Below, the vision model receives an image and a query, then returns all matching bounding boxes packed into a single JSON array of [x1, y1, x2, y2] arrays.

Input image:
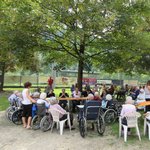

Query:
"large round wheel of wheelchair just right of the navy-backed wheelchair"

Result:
[[104, 109, 117, 124]]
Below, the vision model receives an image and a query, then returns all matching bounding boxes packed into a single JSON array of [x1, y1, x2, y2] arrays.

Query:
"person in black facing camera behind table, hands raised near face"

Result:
[[59, 88, 69, 110]]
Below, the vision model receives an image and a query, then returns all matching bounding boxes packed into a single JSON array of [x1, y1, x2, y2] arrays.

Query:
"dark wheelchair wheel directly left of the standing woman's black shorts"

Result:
[[12, 109, 23, 125]]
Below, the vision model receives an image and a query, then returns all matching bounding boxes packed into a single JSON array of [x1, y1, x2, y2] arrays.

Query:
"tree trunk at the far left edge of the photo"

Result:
[[0, 62, 5, 92]]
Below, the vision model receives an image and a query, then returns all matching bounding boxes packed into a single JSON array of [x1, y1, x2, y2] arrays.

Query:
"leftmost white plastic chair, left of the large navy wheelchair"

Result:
[[50, 109, 71, 135]]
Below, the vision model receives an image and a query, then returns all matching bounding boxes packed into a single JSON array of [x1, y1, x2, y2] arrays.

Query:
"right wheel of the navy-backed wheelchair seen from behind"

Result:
[[97, 115, 105, 135]]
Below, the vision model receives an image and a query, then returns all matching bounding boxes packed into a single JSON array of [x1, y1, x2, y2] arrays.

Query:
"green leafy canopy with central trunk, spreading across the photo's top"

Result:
[[0, 0, 150, 89]]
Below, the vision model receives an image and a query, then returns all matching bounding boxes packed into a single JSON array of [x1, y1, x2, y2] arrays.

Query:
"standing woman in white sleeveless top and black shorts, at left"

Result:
[[22, 82, 36, 129]]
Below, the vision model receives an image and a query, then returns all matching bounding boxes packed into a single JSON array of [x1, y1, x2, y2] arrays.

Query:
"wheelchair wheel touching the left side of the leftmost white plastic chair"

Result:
[[40, 115, 53, 132]]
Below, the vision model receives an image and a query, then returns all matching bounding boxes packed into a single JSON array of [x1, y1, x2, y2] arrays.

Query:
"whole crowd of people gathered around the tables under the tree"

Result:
[[8, 80, 150, 134]]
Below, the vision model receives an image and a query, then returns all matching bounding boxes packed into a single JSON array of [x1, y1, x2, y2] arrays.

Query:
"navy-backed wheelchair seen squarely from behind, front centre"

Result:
[[77, 100, 105, 138]]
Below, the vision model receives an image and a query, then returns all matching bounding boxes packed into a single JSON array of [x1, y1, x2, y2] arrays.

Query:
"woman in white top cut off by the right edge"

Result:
[[144, 80, 150, 112]]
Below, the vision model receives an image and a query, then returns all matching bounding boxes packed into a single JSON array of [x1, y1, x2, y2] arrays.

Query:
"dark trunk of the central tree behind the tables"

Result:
[[78, 60, 83, 91]]
